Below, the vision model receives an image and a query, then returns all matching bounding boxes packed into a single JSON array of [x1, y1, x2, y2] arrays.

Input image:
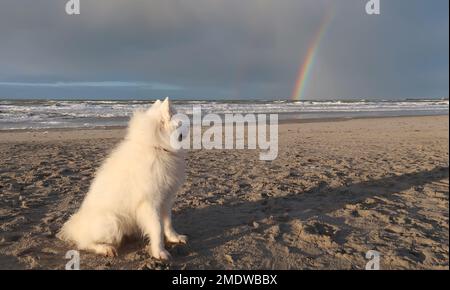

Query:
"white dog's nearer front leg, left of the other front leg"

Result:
[[136, 203, 170, 260]]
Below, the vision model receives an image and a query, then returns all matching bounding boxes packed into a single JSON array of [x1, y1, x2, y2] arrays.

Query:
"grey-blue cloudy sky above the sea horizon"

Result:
[[0, 0, 449, 100]]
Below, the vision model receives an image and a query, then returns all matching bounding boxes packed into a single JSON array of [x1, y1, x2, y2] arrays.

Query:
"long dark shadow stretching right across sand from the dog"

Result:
[[174, 167, 449, 264]]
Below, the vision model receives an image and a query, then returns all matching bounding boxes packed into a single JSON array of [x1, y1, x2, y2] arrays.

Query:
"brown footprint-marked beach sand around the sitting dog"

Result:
[[0, 116, 449, 269]]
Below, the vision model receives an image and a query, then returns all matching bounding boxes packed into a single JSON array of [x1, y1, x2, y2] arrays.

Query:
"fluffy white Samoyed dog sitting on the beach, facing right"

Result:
[[57, 98, 187, 260]]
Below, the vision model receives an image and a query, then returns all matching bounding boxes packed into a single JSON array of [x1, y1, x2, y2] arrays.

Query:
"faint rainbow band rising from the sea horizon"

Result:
[[291, 12, 332, 101]]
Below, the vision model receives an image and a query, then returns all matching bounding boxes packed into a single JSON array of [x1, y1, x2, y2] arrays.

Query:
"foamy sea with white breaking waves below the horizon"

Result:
[[0, 99, 449, 130]]
